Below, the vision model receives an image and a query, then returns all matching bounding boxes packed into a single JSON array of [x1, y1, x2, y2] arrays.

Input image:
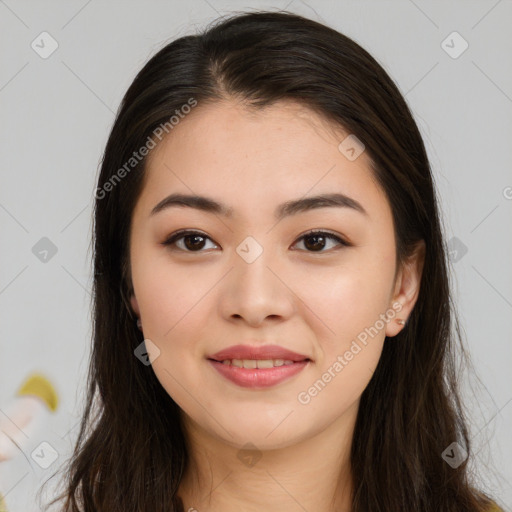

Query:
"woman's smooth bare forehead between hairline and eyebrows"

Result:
[[138, 101, 389, 221]]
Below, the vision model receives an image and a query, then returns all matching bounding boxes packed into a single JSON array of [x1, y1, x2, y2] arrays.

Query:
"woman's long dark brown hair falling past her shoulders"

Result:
[[39, 11, 500, 512]]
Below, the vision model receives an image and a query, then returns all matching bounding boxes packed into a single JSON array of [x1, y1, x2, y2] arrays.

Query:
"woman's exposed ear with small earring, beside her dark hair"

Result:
[[386, 240, 425, 337]]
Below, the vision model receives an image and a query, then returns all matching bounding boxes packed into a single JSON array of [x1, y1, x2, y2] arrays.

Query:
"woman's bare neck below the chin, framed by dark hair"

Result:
[[179, 402, 359, 512]]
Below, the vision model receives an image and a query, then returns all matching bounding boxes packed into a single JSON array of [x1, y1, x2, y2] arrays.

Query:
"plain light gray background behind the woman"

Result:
[[0, 0, 512, 512]]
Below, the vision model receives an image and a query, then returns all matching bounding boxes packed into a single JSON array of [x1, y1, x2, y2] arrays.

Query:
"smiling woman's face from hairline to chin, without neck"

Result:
[[130, 98, 420, 448]]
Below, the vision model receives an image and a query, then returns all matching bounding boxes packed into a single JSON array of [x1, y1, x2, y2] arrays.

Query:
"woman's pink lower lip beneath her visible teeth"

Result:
[[208, 359, 309, 388]]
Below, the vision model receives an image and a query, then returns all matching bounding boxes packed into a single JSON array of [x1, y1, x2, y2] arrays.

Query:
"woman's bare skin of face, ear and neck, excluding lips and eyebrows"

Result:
[[130, 100, 424, 512]]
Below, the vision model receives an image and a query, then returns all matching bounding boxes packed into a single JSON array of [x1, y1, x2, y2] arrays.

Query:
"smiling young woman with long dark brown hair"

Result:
[[42, 12, 502, 512]]
